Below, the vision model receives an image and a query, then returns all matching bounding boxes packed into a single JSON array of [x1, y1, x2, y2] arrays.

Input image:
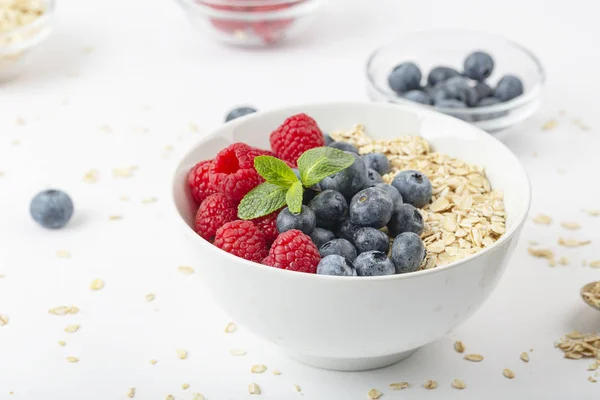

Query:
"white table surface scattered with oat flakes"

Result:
[[0, 0, 600, 400]]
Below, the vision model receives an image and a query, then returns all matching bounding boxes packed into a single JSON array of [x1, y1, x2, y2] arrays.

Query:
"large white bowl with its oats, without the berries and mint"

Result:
[[172, 102, 530, 371]]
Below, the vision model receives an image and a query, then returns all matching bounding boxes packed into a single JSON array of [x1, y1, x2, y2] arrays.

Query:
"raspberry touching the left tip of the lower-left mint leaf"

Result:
[[195, 193, 237, 240]]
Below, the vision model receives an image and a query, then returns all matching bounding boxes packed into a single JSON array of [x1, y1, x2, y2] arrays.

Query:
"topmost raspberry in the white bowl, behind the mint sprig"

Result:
[[271, 114, 325, 166]]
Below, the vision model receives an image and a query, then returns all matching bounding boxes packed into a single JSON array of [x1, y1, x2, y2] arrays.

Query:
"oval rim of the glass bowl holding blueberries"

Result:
[[365, 29, 546, 116]]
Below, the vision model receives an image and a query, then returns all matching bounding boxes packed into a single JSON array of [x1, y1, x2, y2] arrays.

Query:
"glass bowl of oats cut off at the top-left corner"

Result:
[[0, 0, 55, 82]]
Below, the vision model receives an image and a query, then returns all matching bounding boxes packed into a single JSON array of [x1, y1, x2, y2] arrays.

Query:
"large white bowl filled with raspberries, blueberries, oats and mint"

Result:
[[172, 102, 530, 370]]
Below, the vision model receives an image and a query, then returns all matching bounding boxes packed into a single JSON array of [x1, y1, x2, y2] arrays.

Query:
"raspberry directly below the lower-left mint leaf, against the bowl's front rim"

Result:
[[214, 221, 268, 262]]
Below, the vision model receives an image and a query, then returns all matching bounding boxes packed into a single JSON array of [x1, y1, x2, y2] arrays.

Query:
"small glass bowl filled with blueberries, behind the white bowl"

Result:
[[367, 30, 545, 132]]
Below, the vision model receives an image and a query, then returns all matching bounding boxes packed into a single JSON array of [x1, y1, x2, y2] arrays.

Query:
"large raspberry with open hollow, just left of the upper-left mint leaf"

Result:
[[210, 143, 271, 201]]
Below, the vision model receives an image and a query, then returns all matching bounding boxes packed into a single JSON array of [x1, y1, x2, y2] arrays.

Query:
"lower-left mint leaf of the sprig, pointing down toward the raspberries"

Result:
[[238, 182, 288, 220]]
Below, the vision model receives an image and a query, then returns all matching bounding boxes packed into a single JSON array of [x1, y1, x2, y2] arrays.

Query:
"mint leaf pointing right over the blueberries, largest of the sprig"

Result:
[[298, 147, 354, 187]]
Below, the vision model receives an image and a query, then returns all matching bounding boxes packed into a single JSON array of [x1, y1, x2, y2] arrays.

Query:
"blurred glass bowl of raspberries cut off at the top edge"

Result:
[[178, 0, 322, 47]]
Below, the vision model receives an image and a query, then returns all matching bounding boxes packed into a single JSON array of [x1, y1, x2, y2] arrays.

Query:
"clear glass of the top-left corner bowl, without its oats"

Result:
[[0, 0, 55, 82]]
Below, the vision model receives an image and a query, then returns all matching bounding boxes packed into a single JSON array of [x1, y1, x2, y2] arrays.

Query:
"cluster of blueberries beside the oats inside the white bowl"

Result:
[[277, 141, 432, 276]]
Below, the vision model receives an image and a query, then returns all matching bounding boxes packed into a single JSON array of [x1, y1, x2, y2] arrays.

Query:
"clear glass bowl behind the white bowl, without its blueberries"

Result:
[[366, 30, 545, 132]]
